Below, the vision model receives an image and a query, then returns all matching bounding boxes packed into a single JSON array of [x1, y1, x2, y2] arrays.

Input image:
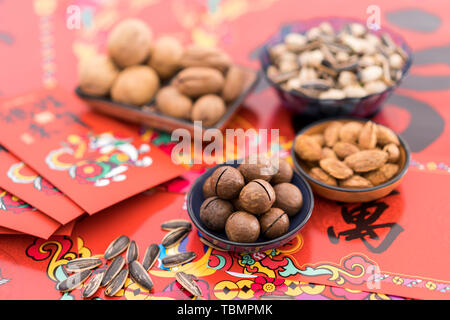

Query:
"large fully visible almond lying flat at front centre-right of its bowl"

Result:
[[344, 149, 388, 172]]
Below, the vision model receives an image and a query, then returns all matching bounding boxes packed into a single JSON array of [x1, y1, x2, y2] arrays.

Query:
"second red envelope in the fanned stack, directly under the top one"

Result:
[[0, 146, 84, 224]]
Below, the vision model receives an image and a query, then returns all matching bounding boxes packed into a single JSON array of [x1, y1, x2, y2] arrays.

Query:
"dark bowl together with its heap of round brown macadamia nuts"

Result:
[[187, 155, 314, 252]]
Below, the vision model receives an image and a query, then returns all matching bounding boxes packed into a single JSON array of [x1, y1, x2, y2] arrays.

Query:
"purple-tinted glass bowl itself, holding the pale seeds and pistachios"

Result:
[[259, 18, 412, 118]]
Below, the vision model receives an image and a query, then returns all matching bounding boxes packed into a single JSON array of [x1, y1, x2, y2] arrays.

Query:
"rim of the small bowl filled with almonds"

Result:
[[291, 116, 411, 193]]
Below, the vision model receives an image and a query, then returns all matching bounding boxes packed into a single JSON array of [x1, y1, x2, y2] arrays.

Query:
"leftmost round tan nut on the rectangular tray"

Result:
[[79, 55, 119, 96]]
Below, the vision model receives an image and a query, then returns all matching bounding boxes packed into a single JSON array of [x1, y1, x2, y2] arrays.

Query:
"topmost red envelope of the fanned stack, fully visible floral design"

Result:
[[0, 88, 185, 214]]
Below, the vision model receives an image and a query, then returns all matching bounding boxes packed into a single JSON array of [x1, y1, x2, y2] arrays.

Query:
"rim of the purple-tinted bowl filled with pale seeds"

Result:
[[258, 16, 413, 103]]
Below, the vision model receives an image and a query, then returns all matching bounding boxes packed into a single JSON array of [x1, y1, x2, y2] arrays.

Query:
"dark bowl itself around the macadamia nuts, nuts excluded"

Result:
[[187, 161, 314, 252]]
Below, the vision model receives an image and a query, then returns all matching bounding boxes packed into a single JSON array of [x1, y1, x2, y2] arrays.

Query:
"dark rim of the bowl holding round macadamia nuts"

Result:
[[186, 160, 314, 248]]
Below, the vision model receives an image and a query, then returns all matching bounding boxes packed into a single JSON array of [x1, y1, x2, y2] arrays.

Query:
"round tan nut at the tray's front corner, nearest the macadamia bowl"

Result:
[[191, 94, 226, 127]]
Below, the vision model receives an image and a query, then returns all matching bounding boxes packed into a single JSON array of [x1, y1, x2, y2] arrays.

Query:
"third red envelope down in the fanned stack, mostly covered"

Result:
[[0, 189, 61, 239]]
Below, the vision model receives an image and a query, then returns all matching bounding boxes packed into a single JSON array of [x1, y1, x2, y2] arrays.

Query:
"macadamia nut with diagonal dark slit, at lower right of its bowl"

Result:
[[259, 208, 289, 239]]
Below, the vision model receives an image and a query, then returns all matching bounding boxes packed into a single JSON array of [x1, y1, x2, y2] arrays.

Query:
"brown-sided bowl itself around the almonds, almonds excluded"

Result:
[[291, 118, 411, 202]]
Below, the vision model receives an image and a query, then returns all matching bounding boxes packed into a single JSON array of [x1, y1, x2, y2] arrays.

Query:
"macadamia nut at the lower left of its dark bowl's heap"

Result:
[[200, 196, 234, 231]]
